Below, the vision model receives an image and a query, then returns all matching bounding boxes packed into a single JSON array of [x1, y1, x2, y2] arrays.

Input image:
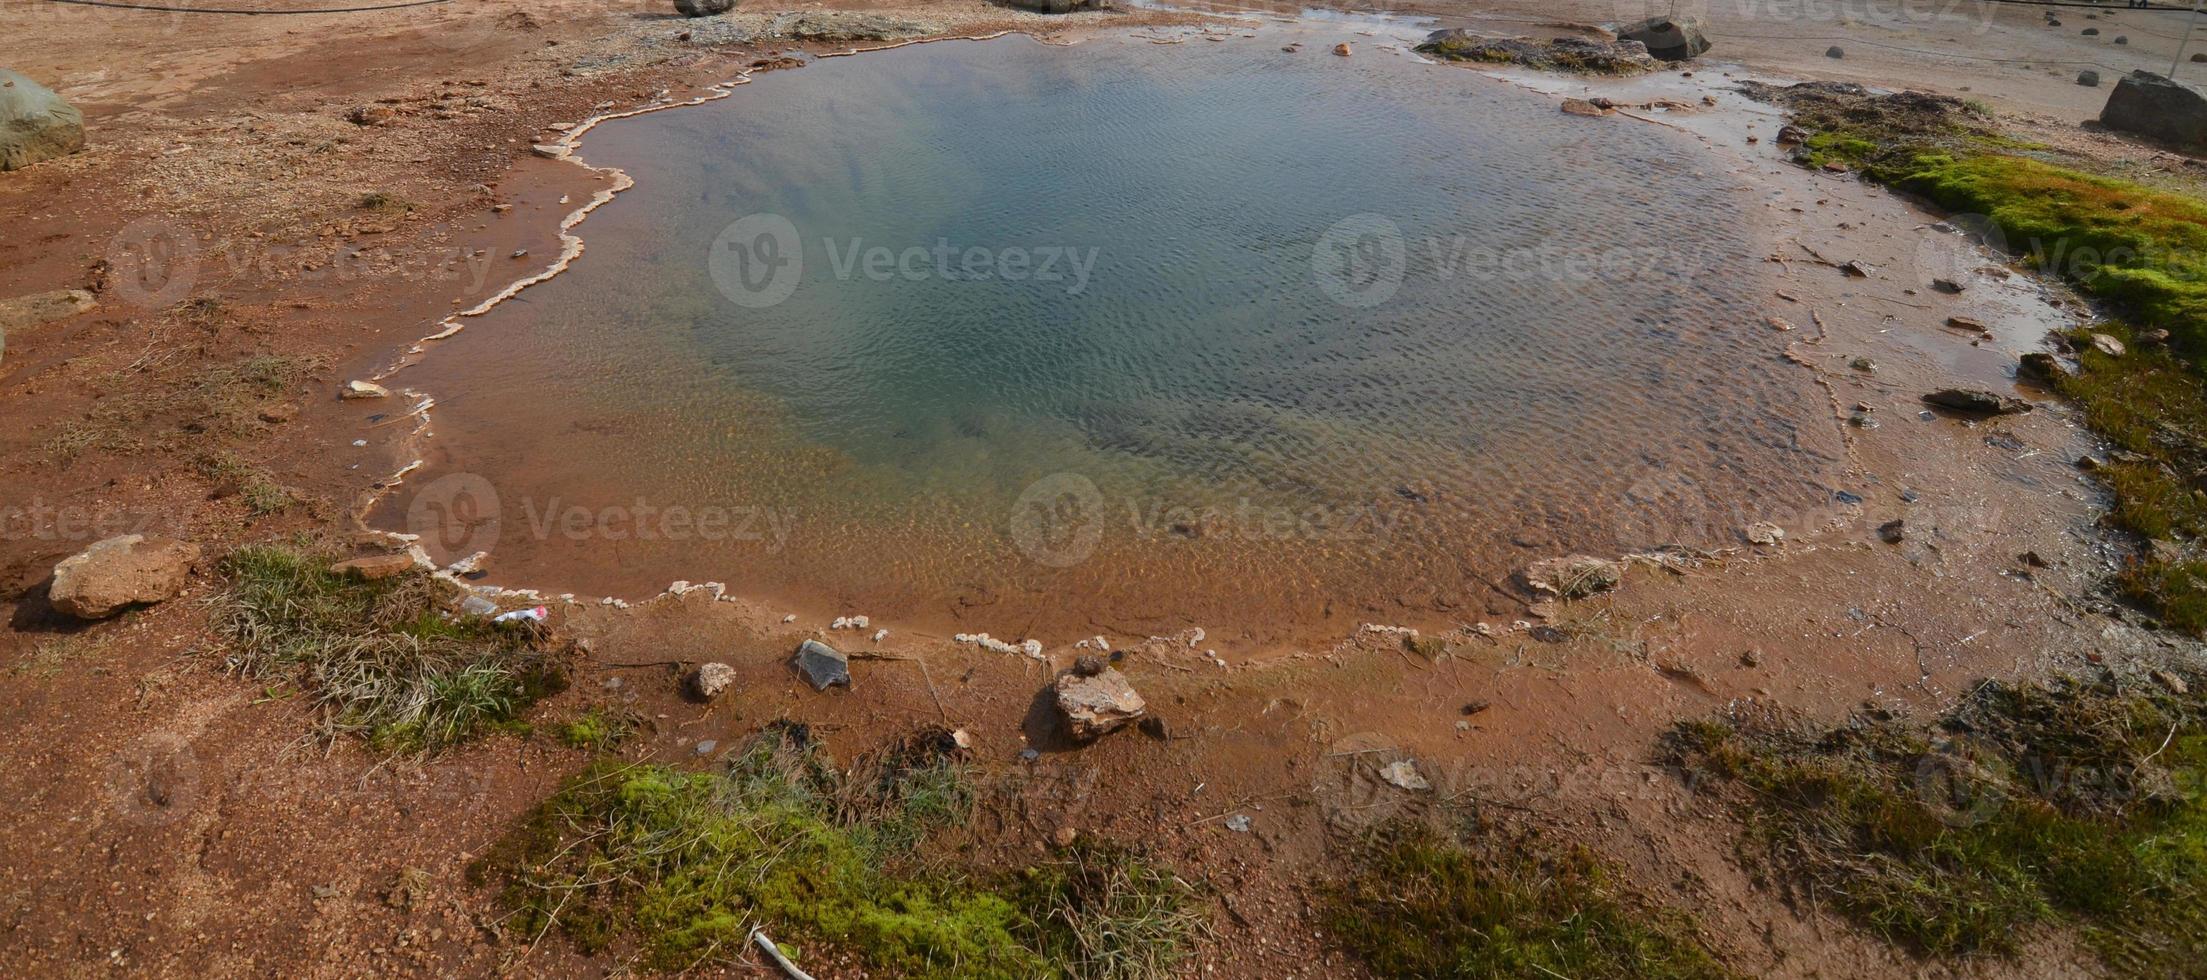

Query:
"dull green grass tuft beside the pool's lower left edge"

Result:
[[214, 545, 565, 753]]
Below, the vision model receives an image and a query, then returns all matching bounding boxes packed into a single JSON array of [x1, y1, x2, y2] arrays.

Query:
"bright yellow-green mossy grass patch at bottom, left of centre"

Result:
[[475, 724, 1201, 978]]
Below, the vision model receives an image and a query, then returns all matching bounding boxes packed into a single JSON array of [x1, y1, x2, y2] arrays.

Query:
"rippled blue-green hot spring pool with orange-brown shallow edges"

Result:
[[392, 33, 1838, 642]]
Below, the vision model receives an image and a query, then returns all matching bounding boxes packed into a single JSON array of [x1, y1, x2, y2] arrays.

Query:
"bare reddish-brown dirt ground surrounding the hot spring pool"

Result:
[[0, 0, 2198, 976]]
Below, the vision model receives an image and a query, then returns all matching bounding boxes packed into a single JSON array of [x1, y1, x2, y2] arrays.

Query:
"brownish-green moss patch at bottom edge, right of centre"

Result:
[[1322, 821, 1732, 978]]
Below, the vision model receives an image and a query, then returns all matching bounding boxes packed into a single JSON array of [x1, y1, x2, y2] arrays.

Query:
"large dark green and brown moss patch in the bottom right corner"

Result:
[[1666, 680, 2207, 976]]
